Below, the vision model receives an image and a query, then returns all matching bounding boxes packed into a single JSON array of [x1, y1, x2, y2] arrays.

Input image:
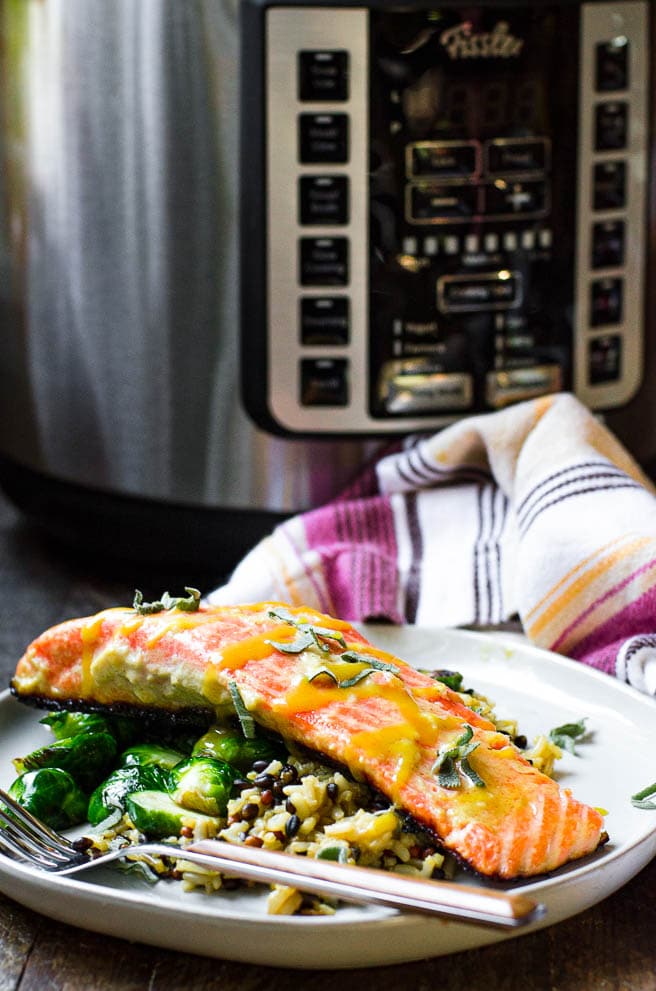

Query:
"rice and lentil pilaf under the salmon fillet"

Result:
[[83, 691, 561, 915]]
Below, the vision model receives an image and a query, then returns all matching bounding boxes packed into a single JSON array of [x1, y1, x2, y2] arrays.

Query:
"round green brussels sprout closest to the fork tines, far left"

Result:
[[9, 767, 87, 829]]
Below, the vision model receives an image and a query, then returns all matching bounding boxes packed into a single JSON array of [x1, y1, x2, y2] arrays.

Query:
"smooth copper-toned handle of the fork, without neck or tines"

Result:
[[179, 840, 545, 928]]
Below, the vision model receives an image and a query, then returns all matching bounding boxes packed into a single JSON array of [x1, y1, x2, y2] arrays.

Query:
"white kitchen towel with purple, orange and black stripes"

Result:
[[208, 393, 656, 694]]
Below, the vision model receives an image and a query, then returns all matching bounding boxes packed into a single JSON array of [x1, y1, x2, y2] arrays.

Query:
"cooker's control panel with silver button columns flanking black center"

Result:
[[253, 0, 648, 434]]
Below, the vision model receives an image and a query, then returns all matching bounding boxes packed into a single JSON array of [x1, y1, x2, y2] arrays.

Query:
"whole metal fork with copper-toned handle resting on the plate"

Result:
[[0, 789, 545, 928]]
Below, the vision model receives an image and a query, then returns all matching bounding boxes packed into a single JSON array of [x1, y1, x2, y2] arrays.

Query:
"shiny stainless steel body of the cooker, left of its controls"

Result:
[[0, 0, 380, 511]]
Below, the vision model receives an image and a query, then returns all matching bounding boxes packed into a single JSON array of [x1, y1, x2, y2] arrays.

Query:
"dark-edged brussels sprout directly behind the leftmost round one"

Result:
[[13, 733, 116, 792]]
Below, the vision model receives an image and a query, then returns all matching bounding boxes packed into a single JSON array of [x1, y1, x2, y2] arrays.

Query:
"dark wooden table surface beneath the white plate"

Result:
[[0, 496, 656, 991]]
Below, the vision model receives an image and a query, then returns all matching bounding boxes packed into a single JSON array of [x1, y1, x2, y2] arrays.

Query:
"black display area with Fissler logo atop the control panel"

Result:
[[372, 8, 555, 140]]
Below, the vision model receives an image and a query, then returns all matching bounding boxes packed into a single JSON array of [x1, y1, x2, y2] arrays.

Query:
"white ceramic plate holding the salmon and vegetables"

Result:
[[0, 626, 656, 969]]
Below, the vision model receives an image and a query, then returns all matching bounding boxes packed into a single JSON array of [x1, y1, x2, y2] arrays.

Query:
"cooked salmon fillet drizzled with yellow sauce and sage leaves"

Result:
[[12, 603, 604, 879]]
